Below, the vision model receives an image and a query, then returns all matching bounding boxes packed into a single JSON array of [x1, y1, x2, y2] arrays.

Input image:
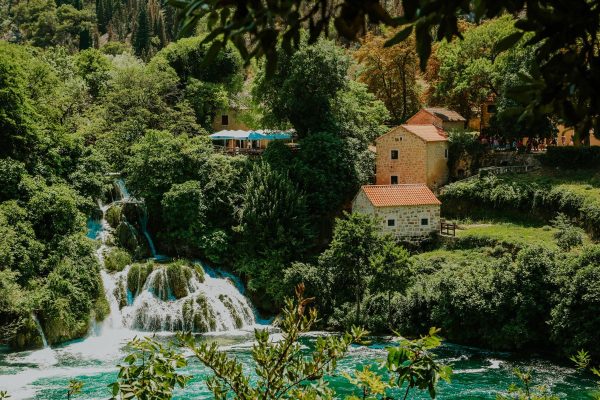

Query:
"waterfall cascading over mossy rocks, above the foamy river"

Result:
[[96, 179, 256, 332]]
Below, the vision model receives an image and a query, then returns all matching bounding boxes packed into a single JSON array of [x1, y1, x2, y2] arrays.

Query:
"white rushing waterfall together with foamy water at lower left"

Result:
[[0, 180, 265, 399]]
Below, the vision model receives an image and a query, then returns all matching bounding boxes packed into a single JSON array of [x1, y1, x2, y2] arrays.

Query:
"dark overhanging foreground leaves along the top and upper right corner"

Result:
[[171, 0, 600, 136]]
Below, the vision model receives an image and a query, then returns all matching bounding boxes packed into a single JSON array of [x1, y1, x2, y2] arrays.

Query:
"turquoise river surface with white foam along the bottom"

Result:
[[0, 328, 597, 400]]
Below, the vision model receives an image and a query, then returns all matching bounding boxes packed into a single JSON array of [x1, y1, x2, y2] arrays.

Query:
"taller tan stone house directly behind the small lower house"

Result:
[[375, 124, 448, 190]]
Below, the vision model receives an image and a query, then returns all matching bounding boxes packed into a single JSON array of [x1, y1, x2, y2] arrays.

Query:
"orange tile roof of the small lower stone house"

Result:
[[361, 184, 442, 207]]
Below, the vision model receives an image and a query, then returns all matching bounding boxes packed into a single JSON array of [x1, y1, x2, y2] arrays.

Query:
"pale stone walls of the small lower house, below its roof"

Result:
[[352, 190, 440, 241]]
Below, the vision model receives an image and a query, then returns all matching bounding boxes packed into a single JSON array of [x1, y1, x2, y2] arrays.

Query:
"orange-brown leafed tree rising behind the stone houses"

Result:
[[354, 29, 420, 124]]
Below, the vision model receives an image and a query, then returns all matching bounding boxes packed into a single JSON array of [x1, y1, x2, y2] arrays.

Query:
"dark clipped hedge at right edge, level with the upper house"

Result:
[[540, 146, 600, 169]]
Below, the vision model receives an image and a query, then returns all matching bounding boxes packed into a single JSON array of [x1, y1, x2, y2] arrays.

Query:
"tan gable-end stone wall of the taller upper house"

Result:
[[375, 126, 427, 185]]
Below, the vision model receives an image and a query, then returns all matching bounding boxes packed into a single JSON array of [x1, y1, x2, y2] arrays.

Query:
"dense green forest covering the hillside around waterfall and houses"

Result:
[[0, 0, 600, 396]]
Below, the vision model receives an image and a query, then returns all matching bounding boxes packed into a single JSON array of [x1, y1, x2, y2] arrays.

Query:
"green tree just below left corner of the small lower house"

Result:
[[319, 213, 381, 323]]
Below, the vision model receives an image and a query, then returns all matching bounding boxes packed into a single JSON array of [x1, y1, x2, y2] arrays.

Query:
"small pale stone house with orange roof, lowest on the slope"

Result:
[[352, 184, 442, 242]]
